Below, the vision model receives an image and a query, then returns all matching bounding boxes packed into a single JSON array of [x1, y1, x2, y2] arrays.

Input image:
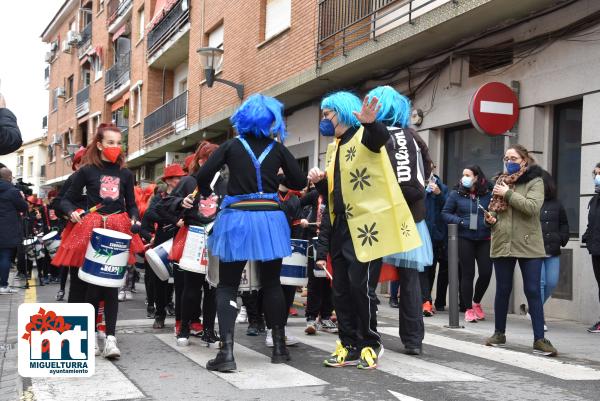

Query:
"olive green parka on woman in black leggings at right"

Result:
[[490, 165, 546, 258]]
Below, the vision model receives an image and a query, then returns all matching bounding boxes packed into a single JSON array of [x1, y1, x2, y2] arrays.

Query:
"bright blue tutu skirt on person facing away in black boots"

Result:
[[208, 208, 292, 262]]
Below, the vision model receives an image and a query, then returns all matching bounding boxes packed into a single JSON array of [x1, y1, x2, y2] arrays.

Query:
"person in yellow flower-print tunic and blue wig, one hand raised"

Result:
[[309, 92, 420, 369]]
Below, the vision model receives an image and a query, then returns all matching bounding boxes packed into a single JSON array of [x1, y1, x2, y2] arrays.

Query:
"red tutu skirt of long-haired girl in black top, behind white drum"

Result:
[[52, 213, 144, 267]]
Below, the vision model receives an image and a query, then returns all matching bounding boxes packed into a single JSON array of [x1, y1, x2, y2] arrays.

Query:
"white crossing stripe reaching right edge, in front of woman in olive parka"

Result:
[[379, 327, 600, 380]]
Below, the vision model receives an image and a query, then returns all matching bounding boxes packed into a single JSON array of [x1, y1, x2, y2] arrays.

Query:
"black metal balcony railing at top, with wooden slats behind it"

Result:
[[316, 0, 458, 64]]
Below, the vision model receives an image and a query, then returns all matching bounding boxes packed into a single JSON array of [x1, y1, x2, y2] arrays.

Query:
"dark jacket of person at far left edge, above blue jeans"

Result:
[[0, 180, 27, 248]]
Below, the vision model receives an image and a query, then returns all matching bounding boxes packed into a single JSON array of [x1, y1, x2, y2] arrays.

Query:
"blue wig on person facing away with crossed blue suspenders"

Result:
[[230, 93, 287, 143]]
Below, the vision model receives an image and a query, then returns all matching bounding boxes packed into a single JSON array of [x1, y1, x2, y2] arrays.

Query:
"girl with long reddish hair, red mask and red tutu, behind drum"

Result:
[[54, 124, 144, 358]]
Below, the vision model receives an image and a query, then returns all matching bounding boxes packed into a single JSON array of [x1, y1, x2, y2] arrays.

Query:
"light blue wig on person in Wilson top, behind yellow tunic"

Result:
[[367, 85, 411, 128]]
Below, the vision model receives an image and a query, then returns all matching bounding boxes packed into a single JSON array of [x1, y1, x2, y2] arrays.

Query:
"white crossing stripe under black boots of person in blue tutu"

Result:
[[156, 333, 329, 390]]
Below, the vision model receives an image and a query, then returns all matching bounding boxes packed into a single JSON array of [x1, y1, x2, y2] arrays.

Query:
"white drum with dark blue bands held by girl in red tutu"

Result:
[[79, 228, 131, 288]]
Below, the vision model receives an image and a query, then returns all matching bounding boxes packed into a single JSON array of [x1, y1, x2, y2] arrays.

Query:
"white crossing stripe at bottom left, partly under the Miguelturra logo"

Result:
[[31, 357, 145, 401]]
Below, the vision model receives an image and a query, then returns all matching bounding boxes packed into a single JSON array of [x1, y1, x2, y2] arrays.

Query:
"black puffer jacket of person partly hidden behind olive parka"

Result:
[[540, 199, 569, 256]]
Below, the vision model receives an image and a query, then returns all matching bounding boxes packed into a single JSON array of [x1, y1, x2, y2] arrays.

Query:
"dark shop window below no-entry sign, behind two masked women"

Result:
[[444, 124, 504, 188]]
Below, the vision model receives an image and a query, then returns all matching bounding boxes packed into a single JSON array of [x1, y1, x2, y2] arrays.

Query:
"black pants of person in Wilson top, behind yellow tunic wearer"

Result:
[[398, 268, 425, 348]]
